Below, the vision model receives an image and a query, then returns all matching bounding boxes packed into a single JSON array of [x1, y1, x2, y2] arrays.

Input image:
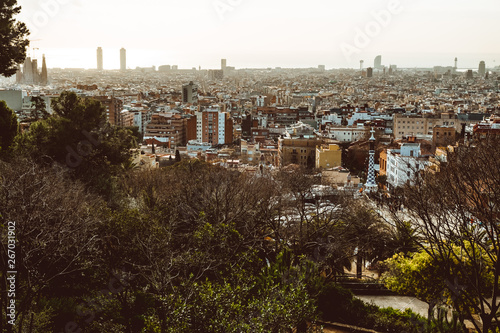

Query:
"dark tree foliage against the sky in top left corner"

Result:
[[0, 0, 29, 77]]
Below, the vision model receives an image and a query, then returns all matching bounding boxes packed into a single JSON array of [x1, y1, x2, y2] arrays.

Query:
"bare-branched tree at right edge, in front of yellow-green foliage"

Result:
[[394, 136, 500, 333]]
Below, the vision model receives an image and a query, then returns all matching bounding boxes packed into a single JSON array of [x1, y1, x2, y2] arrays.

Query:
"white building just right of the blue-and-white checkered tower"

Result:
[[386, 143, 429, 189]]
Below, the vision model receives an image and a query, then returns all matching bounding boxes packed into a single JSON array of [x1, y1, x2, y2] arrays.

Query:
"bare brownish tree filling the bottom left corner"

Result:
[[0, 158, 103, 332]]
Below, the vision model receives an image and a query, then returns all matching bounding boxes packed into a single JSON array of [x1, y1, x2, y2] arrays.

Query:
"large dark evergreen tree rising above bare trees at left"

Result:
[[17, 92, 136, 194]]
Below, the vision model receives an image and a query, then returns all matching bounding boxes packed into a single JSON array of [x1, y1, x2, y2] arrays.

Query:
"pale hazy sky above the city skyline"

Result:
[[18, 0, 500, 69]]
